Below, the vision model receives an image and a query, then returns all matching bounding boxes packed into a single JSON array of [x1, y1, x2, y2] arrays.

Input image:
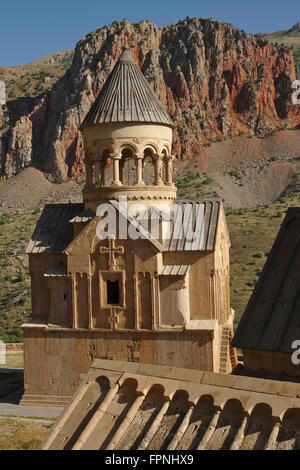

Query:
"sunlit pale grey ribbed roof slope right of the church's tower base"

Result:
[[165, 200, 222, 251]]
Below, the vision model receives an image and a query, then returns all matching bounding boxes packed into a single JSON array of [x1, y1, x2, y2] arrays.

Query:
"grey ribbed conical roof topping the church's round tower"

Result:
[[81, 50, 174, 129]]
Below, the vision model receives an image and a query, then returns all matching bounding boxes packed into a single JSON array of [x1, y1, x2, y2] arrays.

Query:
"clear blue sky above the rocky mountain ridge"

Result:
[[0, 0, 300, 66]]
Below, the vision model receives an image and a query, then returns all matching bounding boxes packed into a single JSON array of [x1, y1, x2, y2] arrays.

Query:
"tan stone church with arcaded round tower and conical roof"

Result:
[[22, 48, 236, 405]]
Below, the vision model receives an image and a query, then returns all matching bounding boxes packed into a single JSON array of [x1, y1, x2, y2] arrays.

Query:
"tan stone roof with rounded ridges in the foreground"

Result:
[[42, 359, 300, 450]]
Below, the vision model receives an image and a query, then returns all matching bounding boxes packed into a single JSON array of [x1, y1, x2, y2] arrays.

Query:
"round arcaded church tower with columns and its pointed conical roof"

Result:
[[81, 48, 176, 211]]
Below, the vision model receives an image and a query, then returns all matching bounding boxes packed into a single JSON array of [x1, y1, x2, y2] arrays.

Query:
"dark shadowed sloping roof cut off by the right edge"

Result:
[[232, 208, 300, 353]]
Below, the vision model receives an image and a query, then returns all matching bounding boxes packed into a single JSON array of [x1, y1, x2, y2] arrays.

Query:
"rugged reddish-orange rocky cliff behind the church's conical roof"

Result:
[[0, 18, 300, 179]]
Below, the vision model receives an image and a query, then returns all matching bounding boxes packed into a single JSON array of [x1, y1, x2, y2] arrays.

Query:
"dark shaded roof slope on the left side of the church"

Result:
[[26, 204, 84, 253]]
